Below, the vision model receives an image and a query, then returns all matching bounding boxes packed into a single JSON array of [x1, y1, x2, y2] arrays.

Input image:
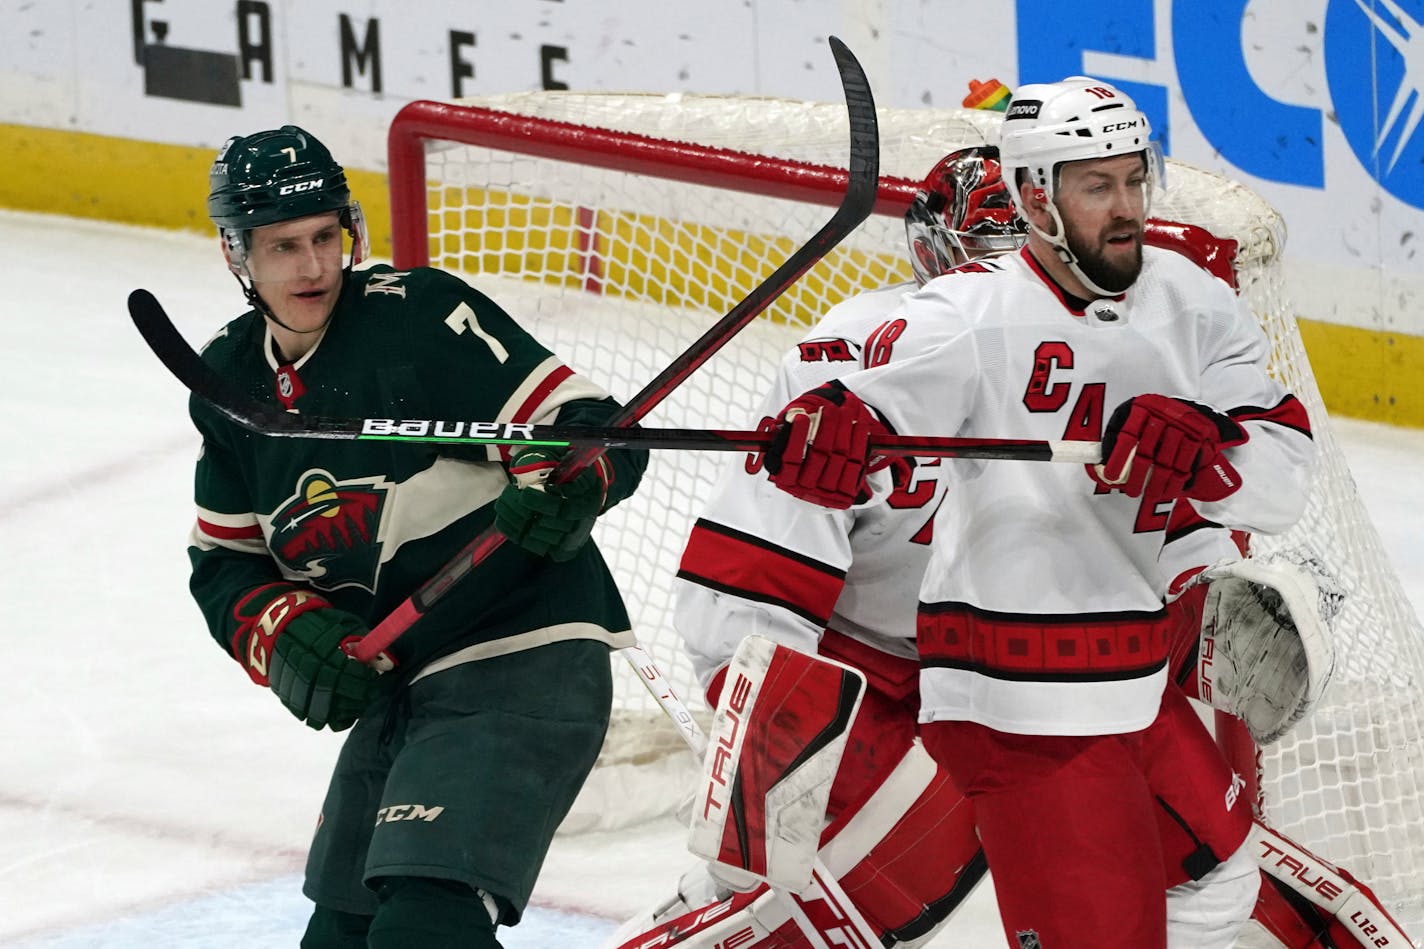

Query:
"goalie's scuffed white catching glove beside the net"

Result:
[[1196, 560, 1341, 745]]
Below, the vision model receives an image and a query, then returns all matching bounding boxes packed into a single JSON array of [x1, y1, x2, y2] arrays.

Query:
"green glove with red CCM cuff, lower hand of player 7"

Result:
[[232, 583, 377, 731]]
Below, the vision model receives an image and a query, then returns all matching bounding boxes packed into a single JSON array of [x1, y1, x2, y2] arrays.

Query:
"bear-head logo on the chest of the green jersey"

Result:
[[271, 470, 390, 593]]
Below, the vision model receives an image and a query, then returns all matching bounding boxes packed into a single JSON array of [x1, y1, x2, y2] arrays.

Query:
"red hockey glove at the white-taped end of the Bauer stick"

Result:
[[1094, 395, 1247, 502]]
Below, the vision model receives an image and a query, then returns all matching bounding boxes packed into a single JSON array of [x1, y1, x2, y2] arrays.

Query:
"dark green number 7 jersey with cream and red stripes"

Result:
[[189, 266, 646, 665]]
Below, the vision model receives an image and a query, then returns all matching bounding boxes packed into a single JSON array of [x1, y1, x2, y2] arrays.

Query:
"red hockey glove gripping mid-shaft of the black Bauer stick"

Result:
[[766, 382, 887, 509]]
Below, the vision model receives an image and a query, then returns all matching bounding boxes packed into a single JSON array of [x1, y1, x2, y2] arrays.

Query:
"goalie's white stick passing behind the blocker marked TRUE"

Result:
[[618, 645, 880, 949]]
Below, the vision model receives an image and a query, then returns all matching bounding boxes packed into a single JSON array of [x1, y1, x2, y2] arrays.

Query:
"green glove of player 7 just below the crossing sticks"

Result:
[[494, 447, 609, 560]]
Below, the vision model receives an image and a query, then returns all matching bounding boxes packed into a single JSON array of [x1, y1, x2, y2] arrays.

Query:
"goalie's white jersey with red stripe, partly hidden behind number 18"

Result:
[[676, 277, 944, 685]]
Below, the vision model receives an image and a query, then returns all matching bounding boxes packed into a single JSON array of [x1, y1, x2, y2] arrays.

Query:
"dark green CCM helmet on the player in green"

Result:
[[208, 125, 370, 278]]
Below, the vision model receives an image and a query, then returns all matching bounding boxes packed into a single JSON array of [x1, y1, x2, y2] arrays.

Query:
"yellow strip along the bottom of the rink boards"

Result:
[[0, 124, 1424, 427]]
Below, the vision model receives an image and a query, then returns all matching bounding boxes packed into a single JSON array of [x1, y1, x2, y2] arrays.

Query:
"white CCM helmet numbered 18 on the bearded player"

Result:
[[998, 76, 1165, 296]]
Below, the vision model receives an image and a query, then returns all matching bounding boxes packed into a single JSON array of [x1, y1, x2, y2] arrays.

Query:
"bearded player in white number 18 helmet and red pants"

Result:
[[768, 80, 1313, 949]]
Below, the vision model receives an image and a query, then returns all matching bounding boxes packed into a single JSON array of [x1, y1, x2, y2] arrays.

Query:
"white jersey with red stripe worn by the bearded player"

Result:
[[842, 247, 1313, 735]]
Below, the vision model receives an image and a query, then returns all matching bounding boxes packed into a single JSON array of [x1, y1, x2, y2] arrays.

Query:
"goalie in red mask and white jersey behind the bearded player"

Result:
[[607, 140, 1412, 949]]
